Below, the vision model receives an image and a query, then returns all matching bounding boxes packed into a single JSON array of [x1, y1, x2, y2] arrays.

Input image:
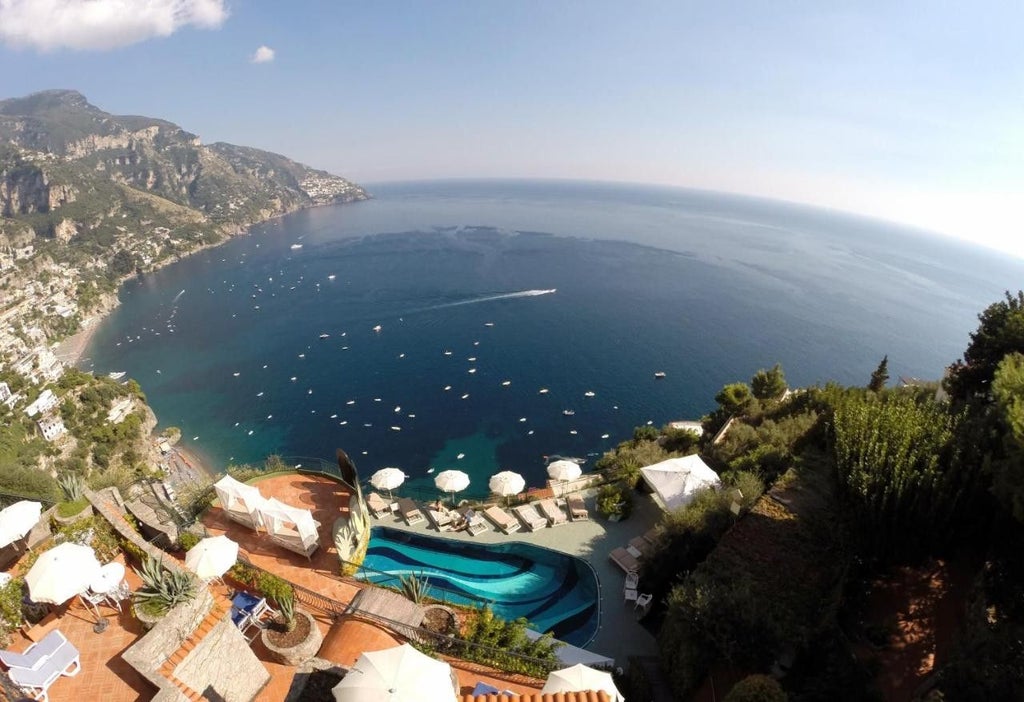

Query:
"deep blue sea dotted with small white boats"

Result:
[[83, 180, 1024, 496]]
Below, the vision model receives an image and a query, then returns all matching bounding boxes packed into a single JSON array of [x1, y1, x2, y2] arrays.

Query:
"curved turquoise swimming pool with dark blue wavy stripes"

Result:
[[360, 527, 600, 647]]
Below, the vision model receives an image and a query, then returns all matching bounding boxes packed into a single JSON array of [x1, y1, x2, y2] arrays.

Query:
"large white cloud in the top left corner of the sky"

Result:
[[0, 0, 227, 51]]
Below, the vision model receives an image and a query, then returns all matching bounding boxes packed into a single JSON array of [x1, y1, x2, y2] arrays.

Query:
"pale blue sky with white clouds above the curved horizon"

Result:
[[0, 0, 1024, 258]]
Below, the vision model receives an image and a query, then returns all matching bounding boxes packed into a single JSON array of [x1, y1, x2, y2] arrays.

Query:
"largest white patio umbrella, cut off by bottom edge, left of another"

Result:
[[331, 644, 456, 702]]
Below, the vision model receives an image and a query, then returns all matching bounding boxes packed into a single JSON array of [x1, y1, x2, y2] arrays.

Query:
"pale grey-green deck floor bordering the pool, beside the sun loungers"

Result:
[[372, 496, 663, 667]]
